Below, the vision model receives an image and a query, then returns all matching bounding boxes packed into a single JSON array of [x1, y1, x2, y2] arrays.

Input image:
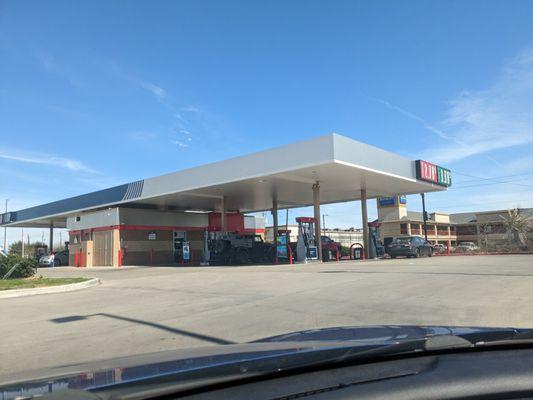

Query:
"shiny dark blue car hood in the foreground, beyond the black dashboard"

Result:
[[0, 325, 533, 399]]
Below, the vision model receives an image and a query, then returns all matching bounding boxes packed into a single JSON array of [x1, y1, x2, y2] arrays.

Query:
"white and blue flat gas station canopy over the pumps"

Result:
[[2, 134, 446, 228]]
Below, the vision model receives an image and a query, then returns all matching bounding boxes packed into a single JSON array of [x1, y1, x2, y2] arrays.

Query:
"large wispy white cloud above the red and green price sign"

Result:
[[425, 50, 533, 162]]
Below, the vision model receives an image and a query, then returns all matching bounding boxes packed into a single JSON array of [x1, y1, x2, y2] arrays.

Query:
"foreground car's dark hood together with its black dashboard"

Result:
[[0, 326, 533, 400]]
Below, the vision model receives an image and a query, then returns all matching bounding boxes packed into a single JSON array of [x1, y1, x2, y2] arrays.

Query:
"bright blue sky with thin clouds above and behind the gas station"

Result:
[[0, 0, 533, 245]]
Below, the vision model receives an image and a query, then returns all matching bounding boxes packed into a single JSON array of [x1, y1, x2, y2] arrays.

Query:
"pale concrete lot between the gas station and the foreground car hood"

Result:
[[0, 255, 533, 381]]
